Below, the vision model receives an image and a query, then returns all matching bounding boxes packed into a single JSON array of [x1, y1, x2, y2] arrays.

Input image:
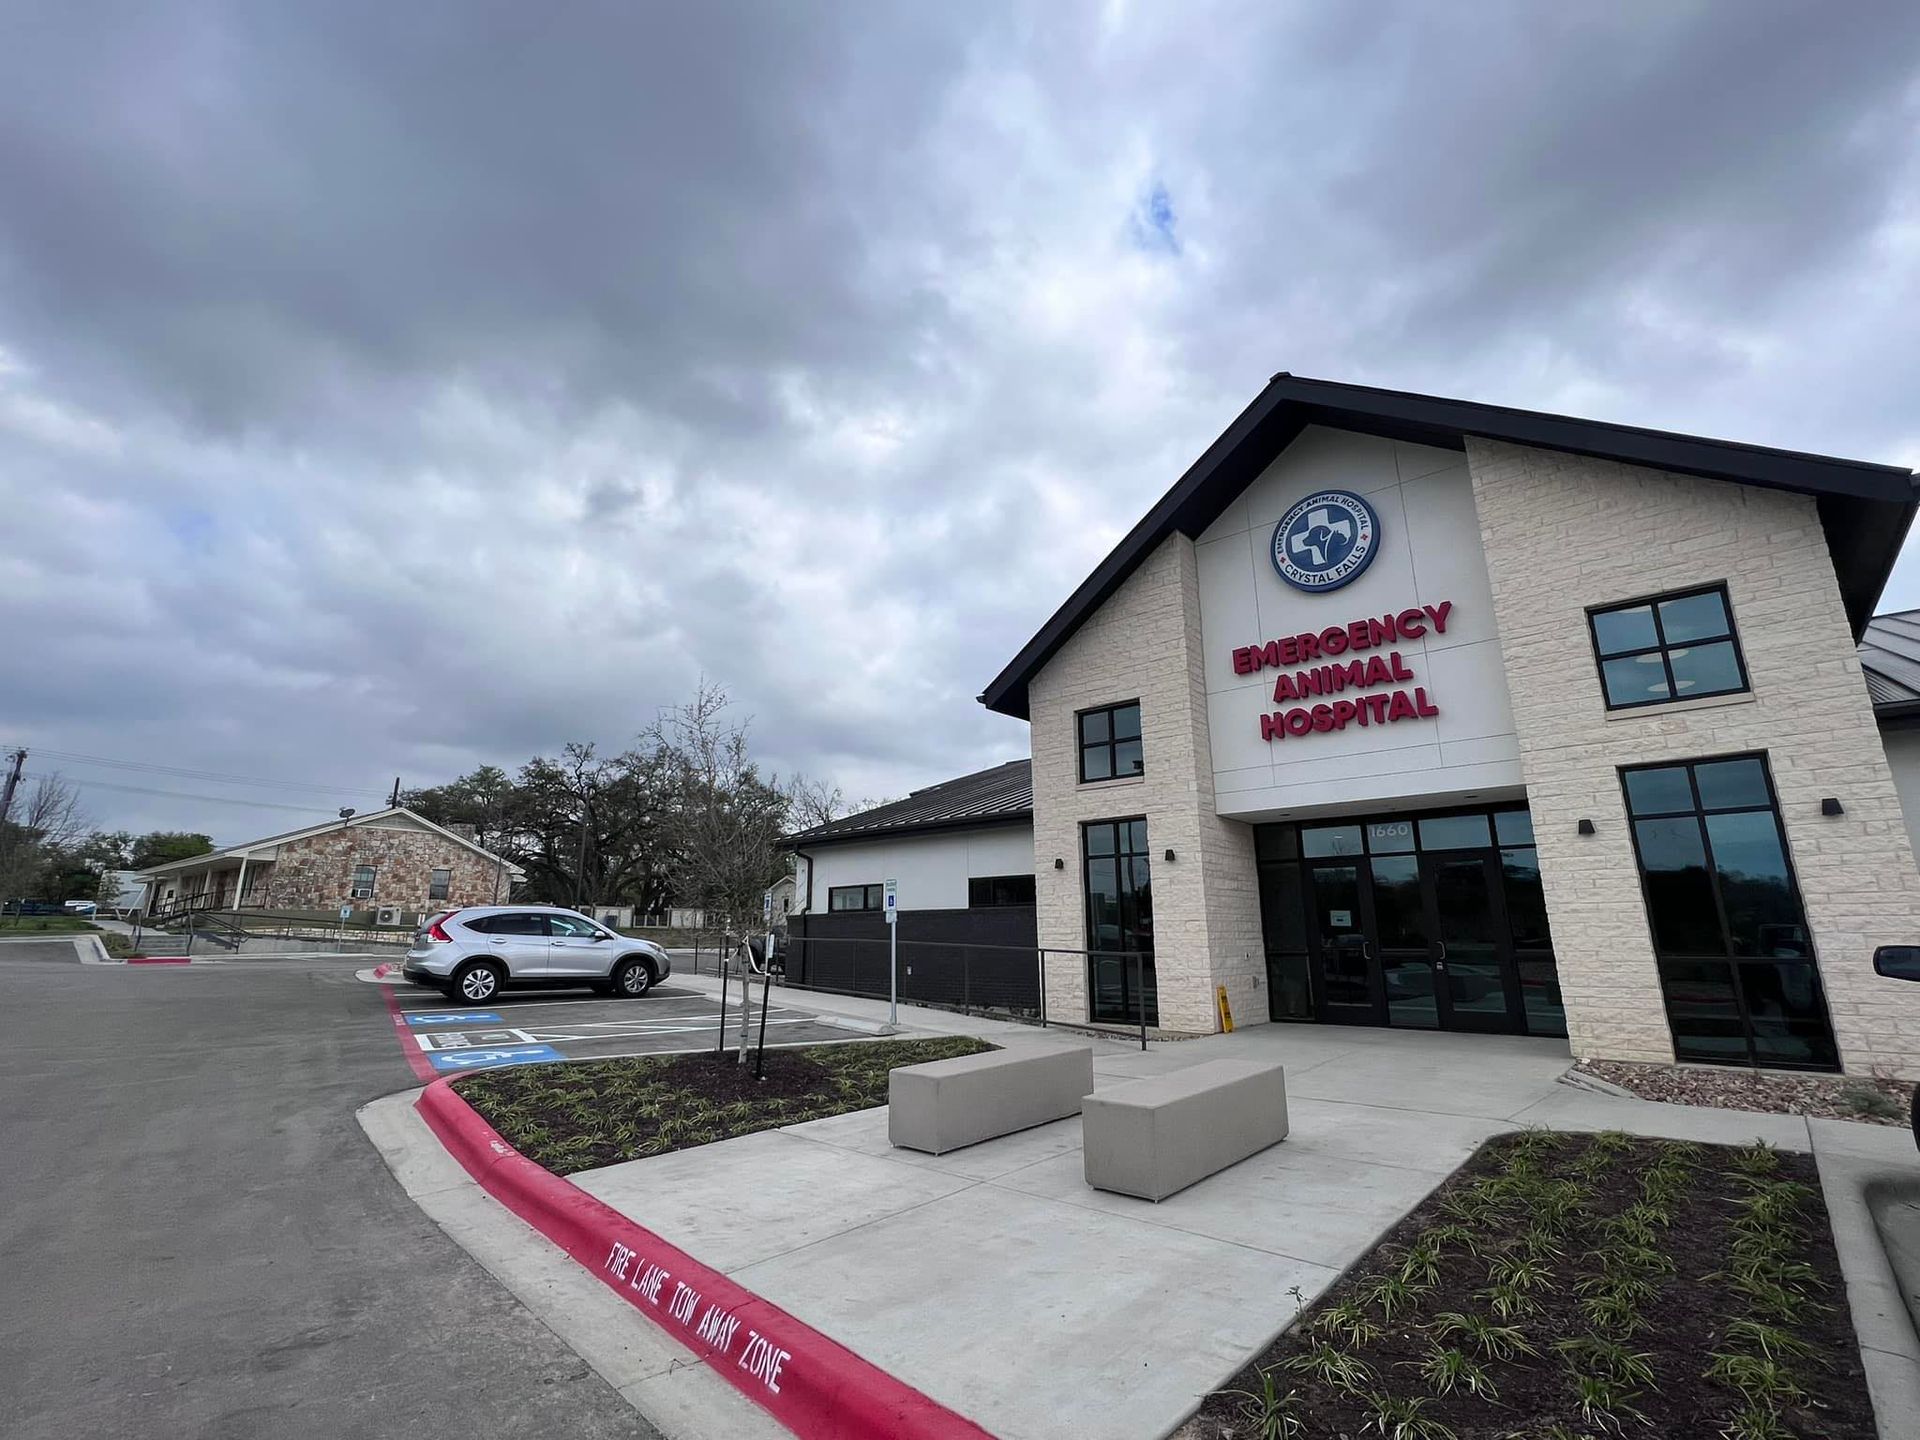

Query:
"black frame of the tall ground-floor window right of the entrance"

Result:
[[1617, 751, 1841, 1073]]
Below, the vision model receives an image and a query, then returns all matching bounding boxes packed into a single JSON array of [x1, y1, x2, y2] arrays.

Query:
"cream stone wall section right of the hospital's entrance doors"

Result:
[[1467, 438, 1920, 1077]]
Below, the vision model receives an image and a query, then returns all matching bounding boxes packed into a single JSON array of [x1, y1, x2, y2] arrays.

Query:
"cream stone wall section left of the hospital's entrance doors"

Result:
[[1027, 536, 1267, 1031]]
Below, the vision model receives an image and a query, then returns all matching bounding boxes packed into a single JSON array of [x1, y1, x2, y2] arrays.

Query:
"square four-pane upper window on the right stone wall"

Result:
[[1586, 586, 1749, 710]]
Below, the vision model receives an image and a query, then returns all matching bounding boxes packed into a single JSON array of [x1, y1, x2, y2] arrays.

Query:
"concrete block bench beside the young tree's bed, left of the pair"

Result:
[[887, 1041, 1092, 1156]]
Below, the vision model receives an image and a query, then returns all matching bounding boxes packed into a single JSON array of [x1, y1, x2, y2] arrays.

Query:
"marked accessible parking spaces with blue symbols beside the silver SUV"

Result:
[[392, 981, 858, 1073]]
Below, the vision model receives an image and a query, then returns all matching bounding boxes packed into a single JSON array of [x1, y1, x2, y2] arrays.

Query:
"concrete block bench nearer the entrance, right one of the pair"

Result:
[[1081, 1060, 1286, 1200]]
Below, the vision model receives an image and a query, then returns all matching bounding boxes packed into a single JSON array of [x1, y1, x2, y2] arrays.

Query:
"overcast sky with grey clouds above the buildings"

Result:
[[0, 0, 1920, 841]]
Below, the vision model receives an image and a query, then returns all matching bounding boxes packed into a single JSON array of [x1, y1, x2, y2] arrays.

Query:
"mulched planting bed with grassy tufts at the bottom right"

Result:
[[1181, 1131, 1874, 1440]]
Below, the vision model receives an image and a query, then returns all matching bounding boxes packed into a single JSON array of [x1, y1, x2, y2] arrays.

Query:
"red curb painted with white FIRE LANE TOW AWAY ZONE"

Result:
[[417, 1079, 993, 1440]]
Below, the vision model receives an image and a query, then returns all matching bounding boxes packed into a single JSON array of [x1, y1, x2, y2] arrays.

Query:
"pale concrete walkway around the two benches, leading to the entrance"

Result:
[[574, 1013, 1920, 1440]]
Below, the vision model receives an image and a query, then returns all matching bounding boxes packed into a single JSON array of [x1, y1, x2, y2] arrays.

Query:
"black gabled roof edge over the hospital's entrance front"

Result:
[[979, 371, 1914, 720]]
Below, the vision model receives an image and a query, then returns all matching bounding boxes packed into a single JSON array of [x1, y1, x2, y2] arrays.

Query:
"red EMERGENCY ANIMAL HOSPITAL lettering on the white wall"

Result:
[[1233, 601, 1453, 741]]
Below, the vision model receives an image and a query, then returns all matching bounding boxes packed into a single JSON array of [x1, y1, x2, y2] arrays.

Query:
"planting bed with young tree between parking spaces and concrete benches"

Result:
[[455, 1035, 995, 1175]]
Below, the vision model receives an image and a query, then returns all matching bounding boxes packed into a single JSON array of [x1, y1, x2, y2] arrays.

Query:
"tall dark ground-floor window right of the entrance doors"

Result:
[[1620, 755, 1839, 1069]]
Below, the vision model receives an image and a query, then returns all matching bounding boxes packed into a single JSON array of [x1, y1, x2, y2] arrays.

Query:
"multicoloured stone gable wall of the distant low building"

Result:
[[248, 824, 513, 912]]
